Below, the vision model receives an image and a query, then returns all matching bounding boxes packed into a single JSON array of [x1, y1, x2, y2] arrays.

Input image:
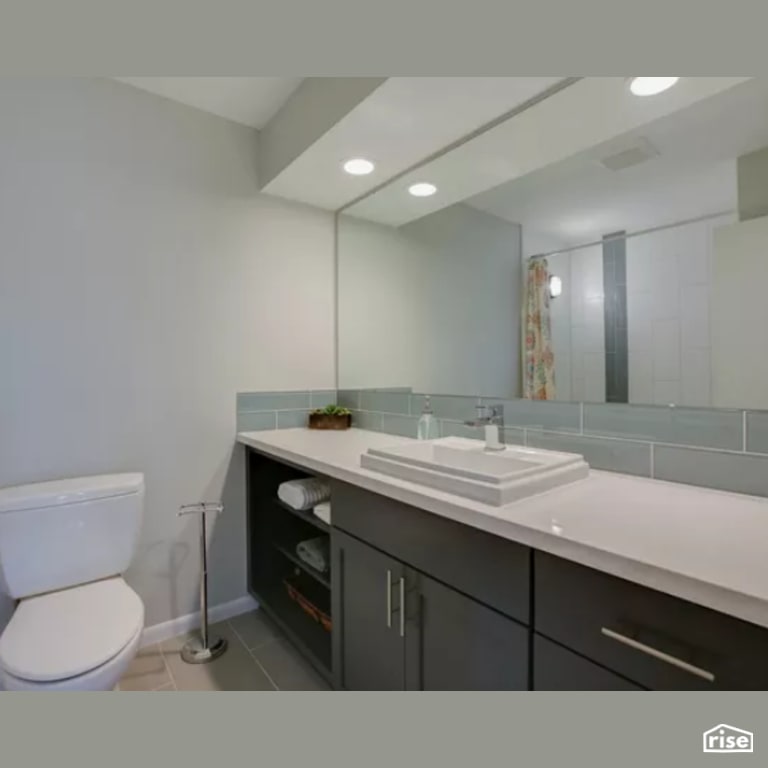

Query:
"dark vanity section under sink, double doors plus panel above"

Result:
[[331, 482, 531, 690]]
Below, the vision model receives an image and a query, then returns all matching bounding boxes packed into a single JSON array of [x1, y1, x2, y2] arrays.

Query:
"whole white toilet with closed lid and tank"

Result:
[[0, 473, 144, 691]]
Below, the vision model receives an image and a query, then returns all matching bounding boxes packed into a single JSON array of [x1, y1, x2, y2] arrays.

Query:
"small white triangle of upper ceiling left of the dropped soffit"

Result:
[[116, 77, 302, 129]]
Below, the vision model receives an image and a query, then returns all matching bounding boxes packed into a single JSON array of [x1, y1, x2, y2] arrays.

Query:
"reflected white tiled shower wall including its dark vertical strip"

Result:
[[547, 214, 735, 407]]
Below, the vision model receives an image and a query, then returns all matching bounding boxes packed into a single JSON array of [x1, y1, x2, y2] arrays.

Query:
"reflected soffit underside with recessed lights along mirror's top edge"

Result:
[[345, 77, 752, 226]]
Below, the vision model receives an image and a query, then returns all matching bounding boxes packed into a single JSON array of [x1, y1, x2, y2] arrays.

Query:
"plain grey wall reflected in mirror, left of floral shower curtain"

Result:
[[338, 204, 521, 397]]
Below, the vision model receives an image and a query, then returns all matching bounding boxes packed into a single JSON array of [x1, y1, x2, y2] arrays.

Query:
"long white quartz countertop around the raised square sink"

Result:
[[237, 429, 768, 627]]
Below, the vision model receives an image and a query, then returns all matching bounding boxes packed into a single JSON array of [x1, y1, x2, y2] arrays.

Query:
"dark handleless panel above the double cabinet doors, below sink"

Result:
[[331, 481, 531, 624]]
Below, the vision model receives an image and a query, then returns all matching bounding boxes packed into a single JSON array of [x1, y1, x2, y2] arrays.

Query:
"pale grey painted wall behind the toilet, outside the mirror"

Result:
[[0, 79, 334, 624]]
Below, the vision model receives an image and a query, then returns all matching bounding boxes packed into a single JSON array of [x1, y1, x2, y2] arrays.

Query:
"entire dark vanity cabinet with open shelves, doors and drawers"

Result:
[[248, 444, 768, 690]]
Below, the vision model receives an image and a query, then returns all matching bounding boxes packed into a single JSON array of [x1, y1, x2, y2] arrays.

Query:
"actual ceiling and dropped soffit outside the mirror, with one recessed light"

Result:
[[117, 77, 564, 210]]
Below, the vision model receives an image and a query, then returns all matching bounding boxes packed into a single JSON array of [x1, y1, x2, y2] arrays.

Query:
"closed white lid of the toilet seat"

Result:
[[0, 576, 144, 681]]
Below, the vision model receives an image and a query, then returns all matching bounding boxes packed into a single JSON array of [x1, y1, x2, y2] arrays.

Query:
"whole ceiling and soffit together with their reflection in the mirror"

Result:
[[111, 77, 768, 225]]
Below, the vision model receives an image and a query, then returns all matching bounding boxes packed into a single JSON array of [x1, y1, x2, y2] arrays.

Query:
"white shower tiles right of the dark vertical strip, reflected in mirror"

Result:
[[627, 216, 728, 406]]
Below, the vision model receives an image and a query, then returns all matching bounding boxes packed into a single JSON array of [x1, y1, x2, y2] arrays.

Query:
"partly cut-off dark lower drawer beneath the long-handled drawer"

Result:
[[533, 635, 644, 691]]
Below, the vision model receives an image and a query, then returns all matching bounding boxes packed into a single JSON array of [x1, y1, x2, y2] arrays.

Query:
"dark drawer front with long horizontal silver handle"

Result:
[[534, 552, 768, 690]]
